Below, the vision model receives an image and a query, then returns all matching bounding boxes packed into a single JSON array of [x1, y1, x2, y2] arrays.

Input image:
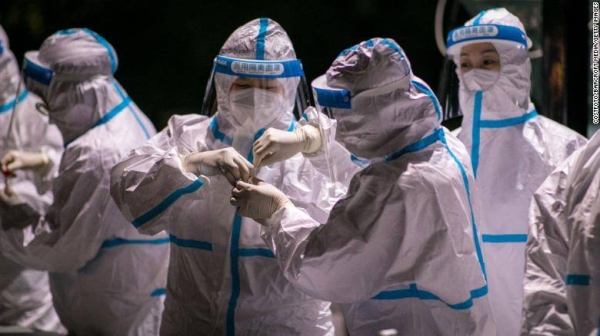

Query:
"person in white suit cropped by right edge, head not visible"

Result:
[[521, 132, 600, 336]]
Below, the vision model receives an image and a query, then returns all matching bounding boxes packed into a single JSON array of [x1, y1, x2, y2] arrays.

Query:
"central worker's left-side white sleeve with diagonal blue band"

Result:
[[111, 116, 206, 234]]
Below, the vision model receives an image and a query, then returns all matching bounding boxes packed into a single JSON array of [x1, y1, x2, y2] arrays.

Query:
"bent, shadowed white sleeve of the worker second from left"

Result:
[[0, 148, 123, 272]]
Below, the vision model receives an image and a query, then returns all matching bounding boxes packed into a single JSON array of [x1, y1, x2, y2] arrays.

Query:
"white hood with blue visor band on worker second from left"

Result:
[[24, 28, 124, 143]]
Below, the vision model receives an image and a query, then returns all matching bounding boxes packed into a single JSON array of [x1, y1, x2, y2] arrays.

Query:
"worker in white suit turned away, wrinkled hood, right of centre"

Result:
[[231, 38, 496, 335]]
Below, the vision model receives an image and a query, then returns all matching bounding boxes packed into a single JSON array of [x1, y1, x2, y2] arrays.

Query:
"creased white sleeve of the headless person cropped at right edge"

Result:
[[521, 162, 575, 335]]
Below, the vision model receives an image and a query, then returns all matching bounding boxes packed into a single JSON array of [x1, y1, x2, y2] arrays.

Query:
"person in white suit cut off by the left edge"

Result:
[[0, 23, 64, 332]]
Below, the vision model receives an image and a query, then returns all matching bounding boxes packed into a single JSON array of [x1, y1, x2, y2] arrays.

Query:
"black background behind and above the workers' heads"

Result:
[[0, 0, 591, 133]]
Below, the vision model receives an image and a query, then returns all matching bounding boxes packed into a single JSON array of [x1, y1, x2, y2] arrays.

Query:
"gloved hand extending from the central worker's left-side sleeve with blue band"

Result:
[[182, 147, 254, 186]]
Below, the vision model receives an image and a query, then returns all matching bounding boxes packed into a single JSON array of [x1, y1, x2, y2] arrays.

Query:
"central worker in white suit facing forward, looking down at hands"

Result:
[[111, 18, 335, 335]]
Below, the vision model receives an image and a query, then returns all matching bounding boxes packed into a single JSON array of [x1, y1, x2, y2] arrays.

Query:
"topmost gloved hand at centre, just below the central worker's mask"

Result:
[[252, 125, 322, 168]]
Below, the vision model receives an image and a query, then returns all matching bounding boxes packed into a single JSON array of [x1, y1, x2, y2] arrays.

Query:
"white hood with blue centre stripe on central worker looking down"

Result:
[[213, 18, 304, 153]]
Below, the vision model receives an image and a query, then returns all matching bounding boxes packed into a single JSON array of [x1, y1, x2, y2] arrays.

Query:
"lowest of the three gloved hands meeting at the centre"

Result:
[[229, 178, 293, 225]]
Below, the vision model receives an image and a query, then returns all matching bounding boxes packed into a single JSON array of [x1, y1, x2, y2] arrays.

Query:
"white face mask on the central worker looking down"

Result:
[[229, 88, 284, 133]]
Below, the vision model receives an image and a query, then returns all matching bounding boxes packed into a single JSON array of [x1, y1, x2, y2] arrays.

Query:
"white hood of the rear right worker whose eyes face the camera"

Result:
[[448, 8, 534, 122]]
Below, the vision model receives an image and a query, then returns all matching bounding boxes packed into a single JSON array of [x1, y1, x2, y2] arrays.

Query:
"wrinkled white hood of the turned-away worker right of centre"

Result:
[[312, 38, 440, 159]]
